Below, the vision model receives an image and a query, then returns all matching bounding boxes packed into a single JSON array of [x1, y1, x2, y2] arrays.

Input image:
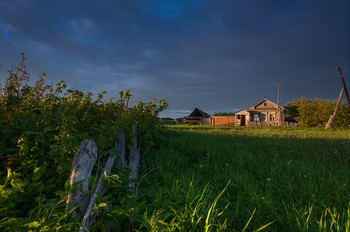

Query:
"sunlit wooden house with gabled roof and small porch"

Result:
[[235, 98, 285, 126]]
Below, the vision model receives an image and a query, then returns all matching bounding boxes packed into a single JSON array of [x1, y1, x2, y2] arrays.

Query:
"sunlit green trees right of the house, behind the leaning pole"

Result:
[[285, 97, 350, 127]]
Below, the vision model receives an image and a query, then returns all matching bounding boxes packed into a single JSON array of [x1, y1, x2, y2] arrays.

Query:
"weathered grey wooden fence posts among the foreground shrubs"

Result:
[[67, 125, 141, 232]]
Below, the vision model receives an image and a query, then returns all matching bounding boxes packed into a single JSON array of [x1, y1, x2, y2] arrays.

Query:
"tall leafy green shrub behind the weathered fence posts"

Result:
[[0, 53, 167, 231]]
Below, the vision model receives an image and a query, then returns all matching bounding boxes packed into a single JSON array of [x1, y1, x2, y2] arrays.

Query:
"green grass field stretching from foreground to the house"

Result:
[[137, 125, 350, 231]]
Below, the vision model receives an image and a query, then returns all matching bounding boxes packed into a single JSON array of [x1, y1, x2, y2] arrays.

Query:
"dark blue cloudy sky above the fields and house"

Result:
[[0, 0, 350, 118]]
